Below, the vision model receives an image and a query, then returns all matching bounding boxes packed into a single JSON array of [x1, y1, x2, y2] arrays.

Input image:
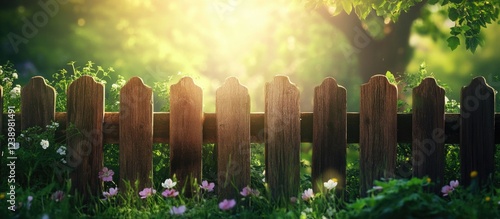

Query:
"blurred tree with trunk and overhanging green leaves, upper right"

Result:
[[304, 0, 500, 81]]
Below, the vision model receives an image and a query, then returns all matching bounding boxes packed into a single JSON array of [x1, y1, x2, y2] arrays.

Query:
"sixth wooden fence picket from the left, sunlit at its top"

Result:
[[264, 76, 300, 201]]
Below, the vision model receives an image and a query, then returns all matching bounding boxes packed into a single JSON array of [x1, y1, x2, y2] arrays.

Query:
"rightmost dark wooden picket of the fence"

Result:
[[460, 77, 495, 185]]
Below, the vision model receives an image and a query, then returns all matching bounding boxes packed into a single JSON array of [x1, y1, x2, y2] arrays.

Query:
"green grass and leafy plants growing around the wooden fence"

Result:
[[0, 62, 500, 218]]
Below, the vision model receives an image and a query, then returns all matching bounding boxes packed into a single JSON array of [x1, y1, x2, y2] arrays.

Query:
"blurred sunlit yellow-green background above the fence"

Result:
[[0, 0, 500, 112]]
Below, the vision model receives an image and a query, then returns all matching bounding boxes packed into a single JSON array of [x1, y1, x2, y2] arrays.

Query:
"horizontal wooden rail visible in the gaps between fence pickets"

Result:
[[3, 112, 500, 144]]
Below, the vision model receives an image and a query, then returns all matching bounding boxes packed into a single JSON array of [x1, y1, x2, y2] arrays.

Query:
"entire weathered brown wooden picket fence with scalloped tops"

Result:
[[0, 75, 500, 198]]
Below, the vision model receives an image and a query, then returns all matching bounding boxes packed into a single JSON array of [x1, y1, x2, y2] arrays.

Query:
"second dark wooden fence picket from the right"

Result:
[[412, 78, 445, 188]]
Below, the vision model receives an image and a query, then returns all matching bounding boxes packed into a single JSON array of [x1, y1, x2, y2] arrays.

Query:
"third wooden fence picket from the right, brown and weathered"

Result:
[[359, 75, 398, 196]]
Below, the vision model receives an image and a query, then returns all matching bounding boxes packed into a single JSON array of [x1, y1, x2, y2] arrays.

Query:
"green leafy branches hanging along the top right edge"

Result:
[[306, 0, 500, 53]]
